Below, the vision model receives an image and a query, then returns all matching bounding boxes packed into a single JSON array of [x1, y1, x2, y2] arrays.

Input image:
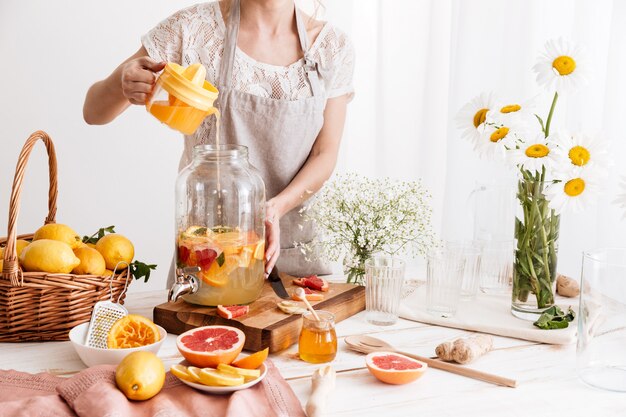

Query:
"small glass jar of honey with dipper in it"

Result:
[[298, 310, 337, 363]]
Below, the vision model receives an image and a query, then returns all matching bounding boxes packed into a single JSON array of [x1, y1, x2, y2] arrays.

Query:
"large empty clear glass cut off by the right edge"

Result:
[[576, 249, 626, 392]]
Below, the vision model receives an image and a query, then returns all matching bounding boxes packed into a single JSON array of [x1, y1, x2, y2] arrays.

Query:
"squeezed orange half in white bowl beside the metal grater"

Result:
[[107, 314, 161, 349]]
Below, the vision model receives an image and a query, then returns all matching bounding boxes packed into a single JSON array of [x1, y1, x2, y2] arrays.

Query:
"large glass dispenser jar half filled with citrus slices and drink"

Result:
[[176, 145, 265, 306]]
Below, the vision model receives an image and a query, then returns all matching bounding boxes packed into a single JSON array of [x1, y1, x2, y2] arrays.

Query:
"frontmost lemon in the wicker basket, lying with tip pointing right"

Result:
[[20, 239, 80, 274]]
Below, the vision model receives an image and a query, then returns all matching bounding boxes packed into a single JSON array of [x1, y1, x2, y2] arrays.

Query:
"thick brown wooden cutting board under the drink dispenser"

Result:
[[154, 273, 365, 352]]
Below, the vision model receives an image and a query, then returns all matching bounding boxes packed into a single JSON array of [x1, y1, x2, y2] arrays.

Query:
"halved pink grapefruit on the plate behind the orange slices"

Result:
[[176, 326, 246, 368]]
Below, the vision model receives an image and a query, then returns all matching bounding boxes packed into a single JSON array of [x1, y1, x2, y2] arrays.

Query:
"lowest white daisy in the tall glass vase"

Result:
[[545, 169, 602, 214]]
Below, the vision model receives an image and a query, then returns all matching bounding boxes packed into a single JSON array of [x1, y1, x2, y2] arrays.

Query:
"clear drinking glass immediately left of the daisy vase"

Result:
[[479, 239, 515, 294]]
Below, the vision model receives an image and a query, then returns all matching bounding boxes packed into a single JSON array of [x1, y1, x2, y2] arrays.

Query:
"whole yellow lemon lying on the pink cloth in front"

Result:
[[115, 351, 165, 401]]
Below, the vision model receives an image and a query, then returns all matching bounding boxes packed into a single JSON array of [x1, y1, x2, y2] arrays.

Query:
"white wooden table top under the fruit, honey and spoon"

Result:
[[0, 291, 626, 417]]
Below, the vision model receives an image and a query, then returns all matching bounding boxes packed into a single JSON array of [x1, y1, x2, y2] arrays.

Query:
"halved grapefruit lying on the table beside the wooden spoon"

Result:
[[365, 352, 428, 385]]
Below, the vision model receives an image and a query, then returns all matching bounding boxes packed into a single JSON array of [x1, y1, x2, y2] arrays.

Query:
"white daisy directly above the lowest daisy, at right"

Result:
[[554, 133, 610, 174]]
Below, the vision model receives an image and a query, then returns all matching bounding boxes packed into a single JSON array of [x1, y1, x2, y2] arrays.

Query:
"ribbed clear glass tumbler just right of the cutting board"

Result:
[[365, 256, 405, 326]]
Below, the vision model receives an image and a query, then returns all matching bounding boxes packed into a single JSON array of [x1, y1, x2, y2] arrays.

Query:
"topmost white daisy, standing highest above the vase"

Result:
[[533, 38, 588, 93]]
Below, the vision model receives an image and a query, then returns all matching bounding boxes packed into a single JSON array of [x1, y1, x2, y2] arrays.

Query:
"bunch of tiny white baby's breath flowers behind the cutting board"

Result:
[[297, 173, 435, 284]]
